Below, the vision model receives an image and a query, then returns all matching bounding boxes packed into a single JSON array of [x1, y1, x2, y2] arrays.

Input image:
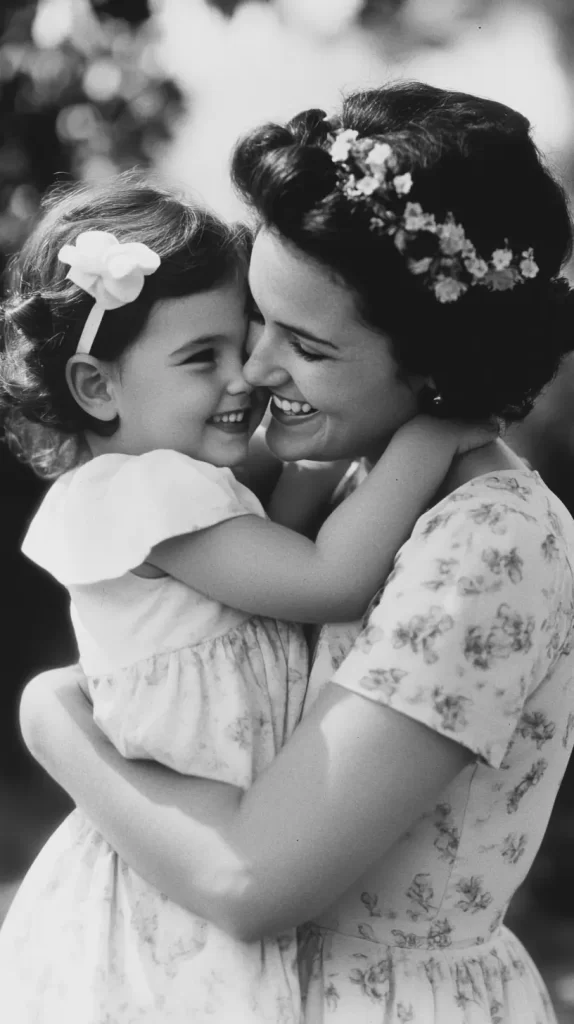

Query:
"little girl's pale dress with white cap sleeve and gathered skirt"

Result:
[[0, 451, 307, 1024]]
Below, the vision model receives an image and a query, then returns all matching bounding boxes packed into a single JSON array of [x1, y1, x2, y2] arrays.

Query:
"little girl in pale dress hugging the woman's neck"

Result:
[[0, 176, 472, 1024]]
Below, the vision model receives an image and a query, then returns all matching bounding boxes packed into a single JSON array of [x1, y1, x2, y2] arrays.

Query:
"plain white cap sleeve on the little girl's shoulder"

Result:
[[21, 450, 265, 587]]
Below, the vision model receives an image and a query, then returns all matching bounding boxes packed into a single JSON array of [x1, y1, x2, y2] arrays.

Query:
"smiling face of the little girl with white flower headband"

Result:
[[107, 283, 264, 466]]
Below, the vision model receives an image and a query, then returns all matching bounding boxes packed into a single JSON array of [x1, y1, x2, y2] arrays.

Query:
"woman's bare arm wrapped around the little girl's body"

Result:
[[21, 670, 472, 941]]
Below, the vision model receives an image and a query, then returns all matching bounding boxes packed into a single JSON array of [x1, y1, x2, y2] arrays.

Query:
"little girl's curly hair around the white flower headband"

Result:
[[0, 172, 249, 477]]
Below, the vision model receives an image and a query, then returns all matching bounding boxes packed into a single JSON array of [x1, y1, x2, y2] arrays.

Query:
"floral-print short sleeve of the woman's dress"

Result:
[[333, 493, 553, 768]]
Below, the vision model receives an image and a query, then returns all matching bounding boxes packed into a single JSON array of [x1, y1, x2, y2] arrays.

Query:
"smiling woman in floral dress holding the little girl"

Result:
[[15, 84, 574, 1024]]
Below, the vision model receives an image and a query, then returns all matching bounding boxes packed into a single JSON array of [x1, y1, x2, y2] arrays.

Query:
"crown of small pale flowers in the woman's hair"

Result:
[[328, 129, 538, 302]]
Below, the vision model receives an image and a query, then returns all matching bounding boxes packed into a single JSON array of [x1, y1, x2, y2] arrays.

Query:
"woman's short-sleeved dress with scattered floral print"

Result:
[[300, 469, 574, 1024]]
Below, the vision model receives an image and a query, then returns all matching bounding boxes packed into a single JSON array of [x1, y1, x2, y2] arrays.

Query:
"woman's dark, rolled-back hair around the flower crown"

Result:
[[232, 82, 574, 421]]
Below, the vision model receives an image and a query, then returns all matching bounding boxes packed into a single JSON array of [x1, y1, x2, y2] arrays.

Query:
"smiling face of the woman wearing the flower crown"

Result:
[[245, 230, 422, 462]]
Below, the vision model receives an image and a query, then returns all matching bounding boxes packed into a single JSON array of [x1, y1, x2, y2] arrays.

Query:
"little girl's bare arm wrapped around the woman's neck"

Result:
[[147, 417, 469, 623]]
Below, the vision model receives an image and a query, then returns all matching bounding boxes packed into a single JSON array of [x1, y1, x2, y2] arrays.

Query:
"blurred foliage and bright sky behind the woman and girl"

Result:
[[0, 0, 574, 1024]]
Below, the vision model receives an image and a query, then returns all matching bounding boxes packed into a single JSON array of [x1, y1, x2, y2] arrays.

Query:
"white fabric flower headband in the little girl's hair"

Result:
[[58, 231, 161, 353]]
